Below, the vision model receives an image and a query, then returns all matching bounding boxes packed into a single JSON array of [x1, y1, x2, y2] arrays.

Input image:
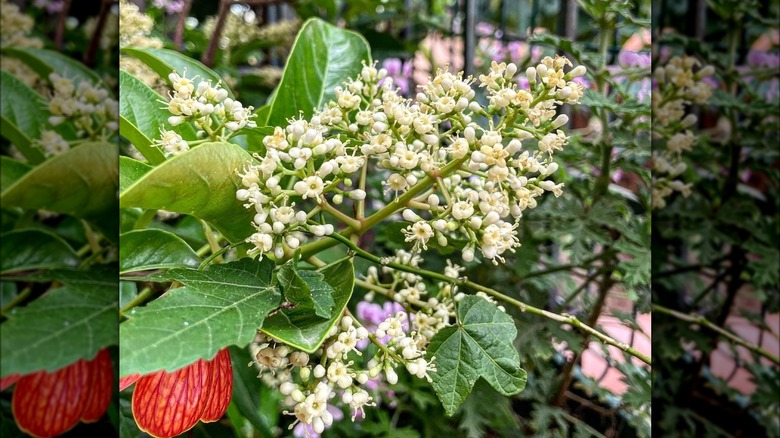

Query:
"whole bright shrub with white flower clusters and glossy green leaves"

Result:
[[120, 0, 649, 436]]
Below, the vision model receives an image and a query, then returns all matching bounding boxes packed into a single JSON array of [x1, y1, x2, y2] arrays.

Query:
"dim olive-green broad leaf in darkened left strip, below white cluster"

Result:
[[0, 143, 119, 239]]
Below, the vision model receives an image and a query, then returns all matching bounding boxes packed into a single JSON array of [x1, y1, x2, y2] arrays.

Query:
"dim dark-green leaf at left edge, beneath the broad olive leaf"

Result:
[[0, 229, 79, 274]]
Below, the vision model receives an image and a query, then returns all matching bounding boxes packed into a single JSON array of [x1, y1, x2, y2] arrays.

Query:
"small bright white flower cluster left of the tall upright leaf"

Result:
[[154, 70, 257, 155]]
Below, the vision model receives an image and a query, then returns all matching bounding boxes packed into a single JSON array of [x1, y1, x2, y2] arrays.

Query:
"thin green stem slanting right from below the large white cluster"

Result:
[[328, 233, 652, 365]]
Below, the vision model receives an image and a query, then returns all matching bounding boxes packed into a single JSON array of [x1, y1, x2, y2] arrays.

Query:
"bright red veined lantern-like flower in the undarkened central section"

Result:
[[119, 349, 233, 438]]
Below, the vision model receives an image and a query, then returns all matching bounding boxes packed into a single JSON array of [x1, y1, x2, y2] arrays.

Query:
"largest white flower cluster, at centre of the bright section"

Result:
[[237, 56, 585, 264]]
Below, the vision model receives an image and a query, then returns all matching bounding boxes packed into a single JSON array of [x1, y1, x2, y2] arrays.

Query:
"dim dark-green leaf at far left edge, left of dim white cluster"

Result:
[[0, 70, 49, 164]]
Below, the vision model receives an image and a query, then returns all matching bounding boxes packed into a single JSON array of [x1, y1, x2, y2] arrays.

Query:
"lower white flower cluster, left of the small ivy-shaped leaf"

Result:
[[250, 308, 434, 433]]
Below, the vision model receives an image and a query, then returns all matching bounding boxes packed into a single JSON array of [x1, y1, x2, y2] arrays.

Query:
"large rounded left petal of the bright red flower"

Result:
[[132, 359, 211, 438]]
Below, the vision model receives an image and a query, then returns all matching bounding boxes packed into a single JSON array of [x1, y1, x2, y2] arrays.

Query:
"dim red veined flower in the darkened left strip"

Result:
[[0, 349, 114, 438]]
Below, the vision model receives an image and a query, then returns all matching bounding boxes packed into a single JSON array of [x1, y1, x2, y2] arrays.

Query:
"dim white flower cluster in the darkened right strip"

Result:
[[652, 56, 715, 209]]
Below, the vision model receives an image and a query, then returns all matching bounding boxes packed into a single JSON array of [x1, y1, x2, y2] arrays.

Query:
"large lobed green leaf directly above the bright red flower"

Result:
[[119, 258, 281, 376]]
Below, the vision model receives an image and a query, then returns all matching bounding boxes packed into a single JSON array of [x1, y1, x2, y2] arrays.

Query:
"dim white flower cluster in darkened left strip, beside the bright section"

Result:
[[49, 73, 119, 139]]
